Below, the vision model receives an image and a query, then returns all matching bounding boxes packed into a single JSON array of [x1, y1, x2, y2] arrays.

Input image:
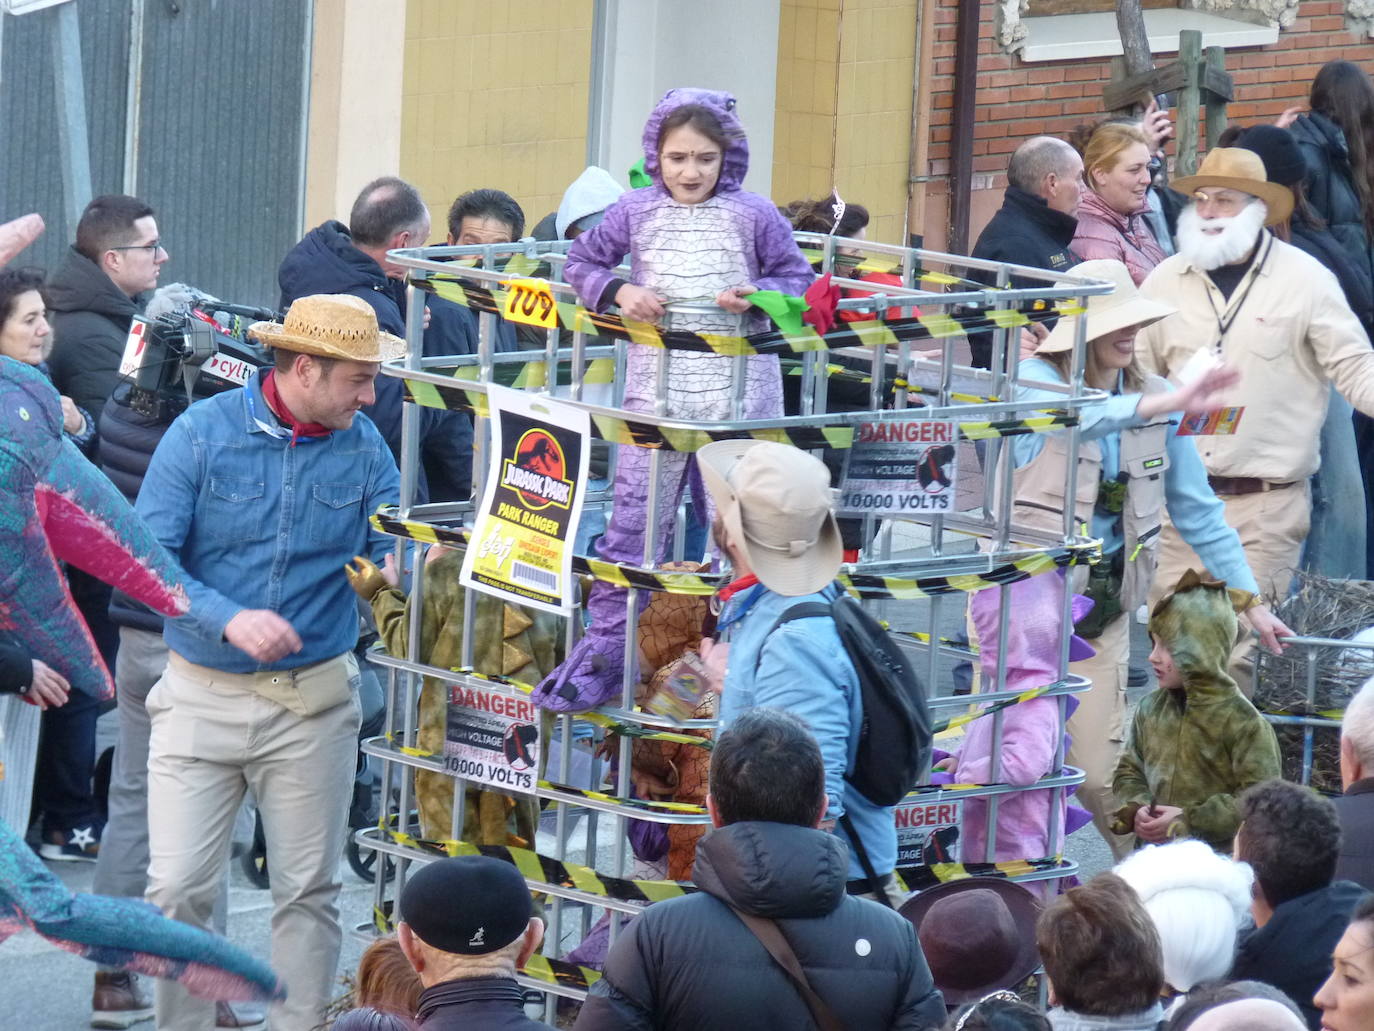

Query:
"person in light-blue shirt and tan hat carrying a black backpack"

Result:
[[697, 440, 900, 905]]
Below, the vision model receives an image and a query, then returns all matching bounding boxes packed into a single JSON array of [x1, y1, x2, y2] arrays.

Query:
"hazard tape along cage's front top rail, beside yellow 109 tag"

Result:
[[420, 278, 1083, 356]]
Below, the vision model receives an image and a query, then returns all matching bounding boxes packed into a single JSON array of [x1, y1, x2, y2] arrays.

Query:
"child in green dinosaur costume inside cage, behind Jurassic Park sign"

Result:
[[348, 546, 563, 848]]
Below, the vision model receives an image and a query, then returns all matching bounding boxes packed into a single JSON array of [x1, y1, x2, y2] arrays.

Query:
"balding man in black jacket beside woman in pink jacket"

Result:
[[969, 136, 1083, 368]]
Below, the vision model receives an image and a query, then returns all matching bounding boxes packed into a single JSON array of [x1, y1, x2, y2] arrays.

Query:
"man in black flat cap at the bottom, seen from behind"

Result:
[[396, 855, 548, 1031]]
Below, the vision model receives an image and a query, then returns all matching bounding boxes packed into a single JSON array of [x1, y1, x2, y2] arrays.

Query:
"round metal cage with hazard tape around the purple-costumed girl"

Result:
[[356, 234, 1112, 1006]]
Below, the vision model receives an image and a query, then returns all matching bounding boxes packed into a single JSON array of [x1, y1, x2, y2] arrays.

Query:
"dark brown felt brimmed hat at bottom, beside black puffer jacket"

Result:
[[900, 877, 1040, 1009]]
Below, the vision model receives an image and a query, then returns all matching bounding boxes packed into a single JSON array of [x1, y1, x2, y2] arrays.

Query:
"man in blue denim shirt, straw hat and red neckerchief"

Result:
[[136, 296, 405, 1031]]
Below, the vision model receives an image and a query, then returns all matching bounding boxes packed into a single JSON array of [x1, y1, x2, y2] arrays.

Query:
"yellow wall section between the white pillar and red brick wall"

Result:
[[774, 0, 918, 243]]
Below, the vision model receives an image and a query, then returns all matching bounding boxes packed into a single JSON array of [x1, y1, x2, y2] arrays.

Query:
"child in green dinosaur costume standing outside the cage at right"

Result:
[[1113, 569, 1281, 852]]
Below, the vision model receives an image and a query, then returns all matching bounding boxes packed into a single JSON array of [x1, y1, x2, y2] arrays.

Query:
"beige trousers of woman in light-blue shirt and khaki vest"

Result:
[[1068, 613, 1134, 859]]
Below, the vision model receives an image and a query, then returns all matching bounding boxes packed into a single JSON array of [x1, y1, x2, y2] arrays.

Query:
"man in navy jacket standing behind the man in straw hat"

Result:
[[276, 176, 477, 502]]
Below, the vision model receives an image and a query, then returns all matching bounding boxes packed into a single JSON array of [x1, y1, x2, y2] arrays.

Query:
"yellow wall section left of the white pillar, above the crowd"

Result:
[[401, 0, 592, 242]]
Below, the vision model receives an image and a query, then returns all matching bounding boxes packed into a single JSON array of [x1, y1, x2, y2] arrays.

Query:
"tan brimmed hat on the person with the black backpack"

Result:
[[697, 440, 845, 598]]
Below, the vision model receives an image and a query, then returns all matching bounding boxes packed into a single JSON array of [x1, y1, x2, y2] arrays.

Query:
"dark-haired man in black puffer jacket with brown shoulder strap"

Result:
[[576, 708, 945, 1031]]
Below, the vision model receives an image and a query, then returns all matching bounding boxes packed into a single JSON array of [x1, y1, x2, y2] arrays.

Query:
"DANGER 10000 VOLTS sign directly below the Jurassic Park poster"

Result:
[[444, 685, 540, 792]]
